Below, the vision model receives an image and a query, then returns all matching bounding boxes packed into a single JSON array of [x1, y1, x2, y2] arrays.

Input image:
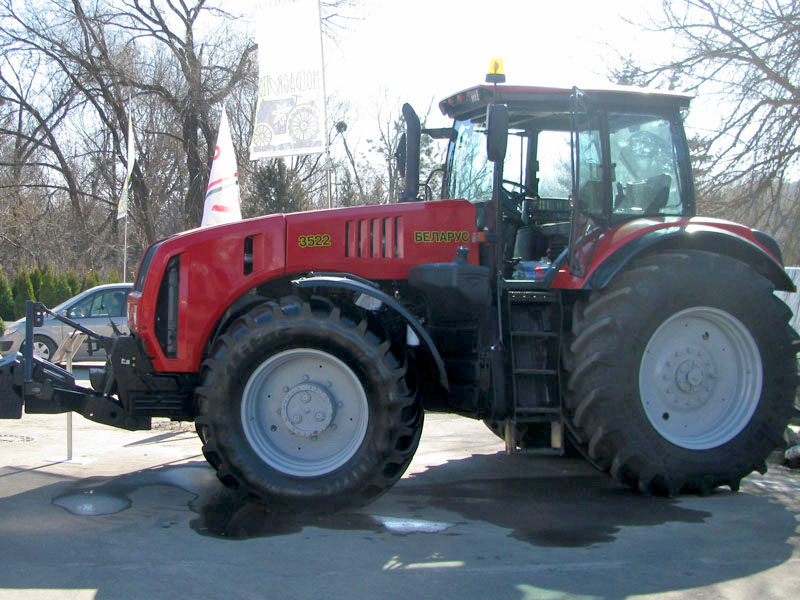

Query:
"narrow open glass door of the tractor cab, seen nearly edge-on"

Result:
[[568, 87, 610, 277]]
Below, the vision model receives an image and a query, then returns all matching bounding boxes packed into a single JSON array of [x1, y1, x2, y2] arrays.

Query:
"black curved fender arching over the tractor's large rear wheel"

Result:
[[584, 225, 795, 292]]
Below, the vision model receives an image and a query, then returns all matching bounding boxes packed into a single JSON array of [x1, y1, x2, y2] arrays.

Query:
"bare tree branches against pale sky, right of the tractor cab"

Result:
[[614, 0, 800, 260]]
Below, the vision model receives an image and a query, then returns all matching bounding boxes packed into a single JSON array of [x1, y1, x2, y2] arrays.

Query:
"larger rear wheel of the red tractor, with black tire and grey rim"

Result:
[[566, 251, 797, 494]]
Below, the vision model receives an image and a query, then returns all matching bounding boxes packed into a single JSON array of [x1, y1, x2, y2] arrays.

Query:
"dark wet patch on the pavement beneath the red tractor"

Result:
[[192, 453, 712, 548]]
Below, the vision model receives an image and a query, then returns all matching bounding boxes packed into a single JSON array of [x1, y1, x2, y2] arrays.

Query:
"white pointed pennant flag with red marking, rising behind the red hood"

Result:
[[200, 106, 242, 227]]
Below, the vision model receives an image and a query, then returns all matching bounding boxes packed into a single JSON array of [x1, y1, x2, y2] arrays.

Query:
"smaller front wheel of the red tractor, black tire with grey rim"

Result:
[[197, 298, 423, 511]]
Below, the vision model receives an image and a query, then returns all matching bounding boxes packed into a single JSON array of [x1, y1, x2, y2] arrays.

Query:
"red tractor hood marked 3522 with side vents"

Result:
[[128, 200, 478, 372]]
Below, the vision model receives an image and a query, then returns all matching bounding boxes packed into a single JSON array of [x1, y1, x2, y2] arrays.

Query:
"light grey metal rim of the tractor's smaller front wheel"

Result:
[[241, 348, 369, 477]]
